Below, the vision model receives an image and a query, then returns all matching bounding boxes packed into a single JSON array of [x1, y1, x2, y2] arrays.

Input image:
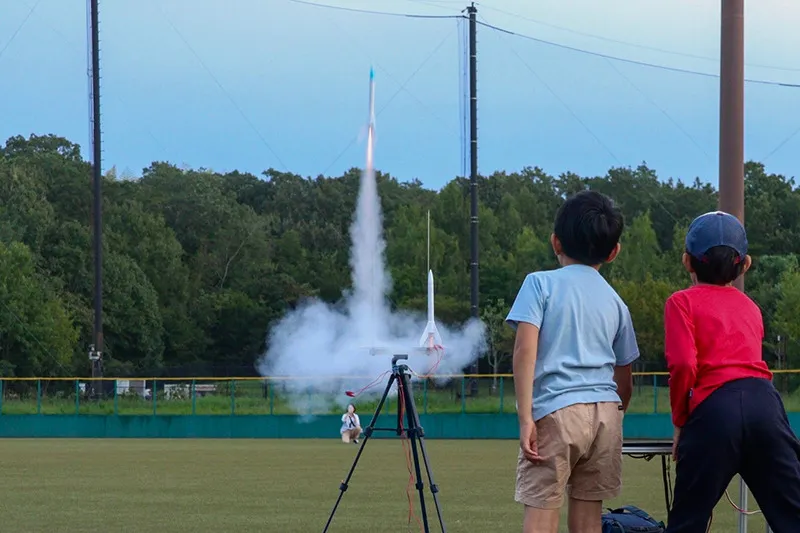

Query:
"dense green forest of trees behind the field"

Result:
[[0, 135, 800, 377]]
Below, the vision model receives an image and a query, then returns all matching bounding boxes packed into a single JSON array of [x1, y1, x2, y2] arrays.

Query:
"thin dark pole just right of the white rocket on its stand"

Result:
[[467, 3, 480, 395]]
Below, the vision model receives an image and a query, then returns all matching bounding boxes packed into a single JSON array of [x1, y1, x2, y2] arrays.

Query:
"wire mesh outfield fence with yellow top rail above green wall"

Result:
[[0, 369, 800, 416]]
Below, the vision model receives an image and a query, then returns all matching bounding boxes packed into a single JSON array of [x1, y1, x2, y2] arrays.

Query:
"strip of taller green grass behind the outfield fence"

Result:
[[0, 376, 800, 415]]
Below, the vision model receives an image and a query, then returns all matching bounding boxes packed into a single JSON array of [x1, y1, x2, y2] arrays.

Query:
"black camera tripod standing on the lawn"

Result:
[[323, 355, 445, 533]]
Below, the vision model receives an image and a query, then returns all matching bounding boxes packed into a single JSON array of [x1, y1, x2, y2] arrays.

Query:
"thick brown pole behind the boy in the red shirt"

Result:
[[719, 0, 747, 533]]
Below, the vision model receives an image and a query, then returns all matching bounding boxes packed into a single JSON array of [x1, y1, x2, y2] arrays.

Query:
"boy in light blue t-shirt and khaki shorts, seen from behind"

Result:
[[506, 191, 639, 533]]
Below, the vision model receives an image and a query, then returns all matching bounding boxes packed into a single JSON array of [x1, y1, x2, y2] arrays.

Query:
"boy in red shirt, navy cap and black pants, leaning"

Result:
[[664, 211, 800, 533]]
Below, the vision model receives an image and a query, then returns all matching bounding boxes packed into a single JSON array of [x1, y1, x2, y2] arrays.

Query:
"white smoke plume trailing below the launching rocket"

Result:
[[258, 131, 485, 414]]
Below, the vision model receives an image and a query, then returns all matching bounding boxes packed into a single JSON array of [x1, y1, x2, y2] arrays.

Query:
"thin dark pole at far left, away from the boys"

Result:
[[89, 0, 103, 392]]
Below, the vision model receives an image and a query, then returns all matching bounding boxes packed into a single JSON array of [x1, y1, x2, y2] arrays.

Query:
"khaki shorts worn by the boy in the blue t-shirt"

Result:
[[515, 402, 624, 509]]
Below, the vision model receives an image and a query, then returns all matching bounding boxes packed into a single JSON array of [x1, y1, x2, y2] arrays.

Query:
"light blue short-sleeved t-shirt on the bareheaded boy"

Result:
[[506, 265, 639, 420]]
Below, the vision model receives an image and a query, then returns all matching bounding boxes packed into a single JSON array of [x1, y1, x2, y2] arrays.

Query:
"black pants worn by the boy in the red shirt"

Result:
[[667, 378, 800, 533]]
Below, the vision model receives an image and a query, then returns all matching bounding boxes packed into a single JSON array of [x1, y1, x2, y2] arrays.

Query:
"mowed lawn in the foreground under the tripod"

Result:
[[0, 439, 765, 533]]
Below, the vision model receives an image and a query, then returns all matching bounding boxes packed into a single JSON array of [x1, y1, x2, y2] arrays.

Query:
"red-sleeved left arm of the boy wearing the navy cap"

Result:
[[664, 295, 697, 428]]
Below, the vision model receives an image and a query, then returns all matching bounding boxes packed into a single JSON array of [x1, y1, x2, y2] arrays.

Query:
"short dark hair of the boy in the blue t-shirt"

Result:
[[554, 191, 625, 266]]
